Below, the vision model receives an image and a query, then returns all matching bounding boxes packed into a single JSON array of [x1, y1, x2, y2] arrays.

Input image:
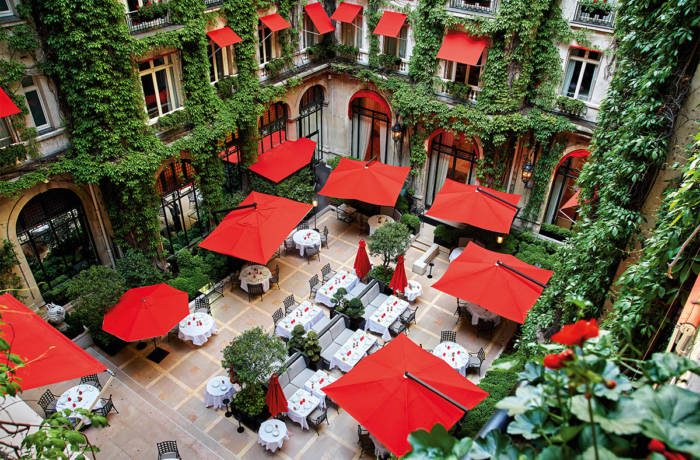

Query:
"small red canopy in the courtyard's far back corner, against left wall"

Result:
[[248, 137, 316, 183]]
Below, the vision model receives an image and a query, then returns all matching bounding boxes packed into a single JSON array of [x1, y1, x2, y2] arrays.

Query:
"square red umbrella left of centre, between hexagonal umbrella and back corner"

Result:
[[199, 192, 312, 264]]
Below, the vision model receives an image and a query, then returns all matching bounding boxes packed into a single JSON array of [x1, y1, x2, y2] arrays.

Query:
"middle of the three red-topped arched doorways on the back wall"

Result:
[[425, 130, 478, 206]]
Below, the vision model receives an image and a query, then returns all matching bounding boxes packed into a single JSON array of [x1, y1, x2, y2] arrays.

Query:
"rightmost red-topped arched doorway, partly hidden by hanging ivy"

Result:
[[544, 149, 590, 228]]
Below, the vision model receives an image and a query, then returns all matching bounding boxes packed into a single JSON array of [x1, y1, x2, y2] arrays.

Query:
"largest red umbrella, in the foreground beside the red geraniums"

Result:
[[323, 334, 488, 456]]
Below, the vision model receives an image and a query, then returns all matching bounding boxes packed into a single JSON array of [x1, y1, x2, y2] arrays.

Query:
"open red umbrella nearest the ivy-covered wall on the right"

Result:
[[433, 243, 552, 324]]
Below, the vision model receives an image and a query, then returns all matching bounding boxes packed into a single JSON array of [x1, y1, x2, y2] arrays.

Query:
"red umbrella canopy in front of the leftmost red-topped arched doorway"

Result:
[[318, 158, 411, 206]]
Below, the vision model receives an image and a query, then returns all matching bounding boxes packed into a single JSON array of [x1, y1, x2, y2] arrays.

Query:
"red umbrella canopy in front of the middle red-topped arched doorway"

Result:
[[425, 179, 520, 233]]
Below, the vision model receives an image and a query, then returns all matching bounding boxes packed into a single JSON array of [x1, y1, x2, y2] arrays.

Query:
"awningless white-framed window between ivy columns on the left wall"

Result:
[[139, 54, 182, 119]]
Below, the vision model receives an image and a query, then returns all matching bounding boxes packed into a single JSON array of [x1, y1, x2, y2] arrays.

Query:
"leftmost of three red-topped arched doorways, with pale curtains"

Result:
[[350, 90, 391, 163]]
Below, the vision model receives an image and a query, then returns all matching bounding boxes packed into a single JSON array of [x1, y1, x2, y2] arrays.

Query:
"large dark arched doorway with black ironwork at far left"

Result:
[[17, 188, 99, 303]]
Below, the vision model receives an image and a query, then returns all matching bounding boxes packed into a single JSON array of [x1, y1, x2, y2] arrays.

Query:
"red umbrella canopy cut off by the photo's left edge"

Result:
[[0, 294, 107, 390]]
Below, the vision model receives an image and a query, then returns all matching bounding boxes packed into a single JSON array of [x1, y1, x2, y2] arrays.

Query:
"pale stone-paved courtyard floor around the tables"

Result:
[[23, 212, 515, 460]]
